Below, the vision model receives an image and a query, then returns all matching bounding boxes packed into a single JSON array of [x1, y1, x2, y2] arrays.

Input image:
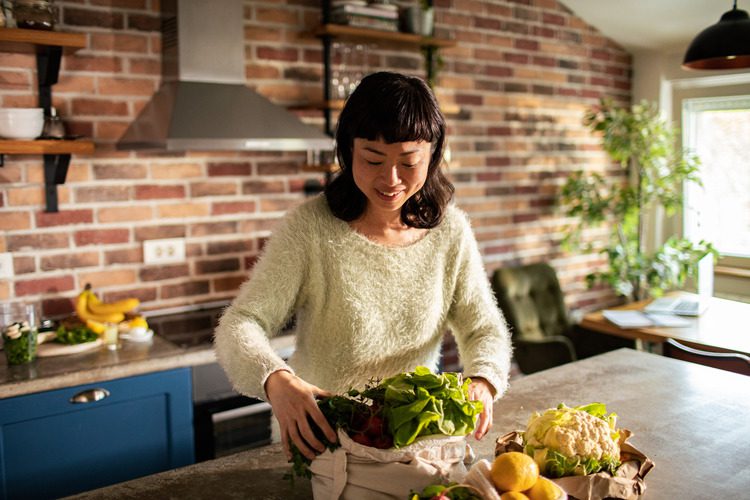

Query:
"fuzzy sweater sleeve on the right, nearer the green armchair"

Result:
[[448, 214, 511, 399]]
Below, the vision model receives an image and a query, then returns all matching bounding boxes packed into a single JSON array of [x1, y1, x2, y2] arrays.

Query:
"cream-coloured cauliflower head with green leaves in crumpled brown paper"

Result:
[[523, 403, 620, 477]]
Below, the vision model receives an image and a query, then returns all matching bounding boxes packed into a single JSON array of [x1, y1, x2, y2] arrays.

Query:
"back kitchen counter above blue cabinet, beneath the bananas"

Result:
[[0, 335, 294, 399]]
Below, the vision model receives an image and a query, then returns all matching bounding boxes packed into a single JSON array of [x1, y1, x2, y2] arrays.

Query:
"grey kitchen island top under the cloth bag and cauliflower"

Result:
[[67, 349, 750, 500]]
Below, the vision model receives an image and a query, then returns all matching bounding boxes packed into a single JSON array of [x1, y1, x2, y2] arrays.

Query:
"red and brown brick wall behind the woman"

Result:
[[0, 0, 631, 315]]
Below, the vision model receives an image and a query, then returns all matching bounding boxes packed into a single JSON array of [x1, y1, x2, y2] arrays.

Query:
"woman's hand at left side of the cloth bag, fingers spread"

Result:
[[266, 370, 337, 460]]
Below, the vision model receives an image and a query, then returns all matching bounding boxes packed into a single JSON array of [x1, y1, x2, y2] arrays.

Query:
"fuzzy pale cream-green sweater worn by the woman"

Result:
[[215, 195, 511, 398]]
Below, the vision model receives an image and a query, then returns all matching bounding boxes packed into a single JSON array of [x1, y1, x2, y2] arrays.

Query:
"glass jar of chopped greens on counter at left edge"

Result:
[[0, 303, 37, 365]]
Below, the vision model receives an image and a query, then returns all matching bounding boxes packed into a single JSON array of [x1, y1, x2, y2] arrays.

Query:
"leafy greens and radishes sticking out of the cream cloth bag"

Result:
[[291, 366, 482, 478]]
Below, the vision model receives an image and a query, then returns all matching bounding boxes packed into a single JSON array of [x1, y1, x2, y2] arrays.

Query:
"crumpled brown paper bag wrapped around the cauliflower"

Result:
[[495, 429, 654, 500]]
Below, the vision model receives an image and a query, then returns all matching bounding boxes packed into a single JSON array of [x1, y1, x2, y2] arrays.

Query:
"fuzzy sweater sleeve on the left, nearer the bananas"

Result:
[[214, 202, 310, 399]]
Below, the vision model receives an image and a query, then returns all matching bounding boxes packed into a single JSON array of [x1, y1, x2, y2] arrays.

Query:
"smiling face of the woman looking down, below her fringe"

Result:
[[352, 139, 431, 218]]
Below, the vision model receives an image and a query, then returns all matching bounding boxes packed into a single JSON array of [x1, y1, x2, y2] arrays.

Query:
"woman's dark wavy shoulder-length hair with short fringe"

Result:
[[325, 71, 454, 229]]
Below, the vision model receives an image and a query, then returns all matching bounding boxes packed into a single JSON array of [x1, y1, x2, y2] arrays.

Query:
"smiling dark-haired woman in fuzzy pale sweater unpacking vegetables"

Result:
[[215, 72, 510, 459]]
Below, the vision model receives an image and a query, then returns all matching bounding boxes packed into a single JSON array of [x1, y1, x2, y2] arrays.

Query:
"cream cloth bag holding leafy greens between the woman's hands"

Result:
[[310, 429, 466, 500]]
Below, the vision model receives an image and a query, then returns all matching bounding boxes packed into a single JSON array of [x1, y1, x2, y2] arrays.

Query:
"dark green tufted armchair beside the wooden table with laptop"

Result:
[[492, 263, 634, 373]]
